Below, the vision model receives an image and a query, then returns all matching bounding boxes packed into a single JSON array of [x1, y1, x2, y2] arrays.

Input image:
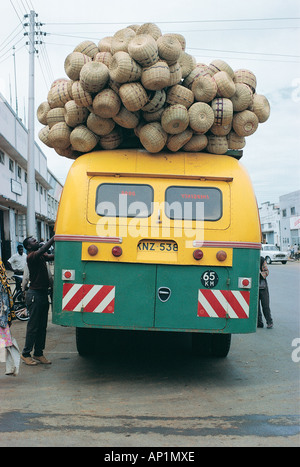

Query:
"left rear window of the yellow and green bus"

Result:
[[96, 183, 153, 217]]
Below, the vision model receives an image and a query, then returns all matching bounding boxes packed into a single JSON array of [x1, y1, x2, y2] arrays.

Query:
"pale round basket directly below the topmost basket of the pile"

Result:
[[128, 34, 159, 67]]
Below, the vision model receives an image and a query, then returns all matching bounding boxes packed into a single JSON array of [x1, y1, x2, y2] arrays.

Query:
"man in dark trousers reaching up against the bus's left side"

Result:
[[21, 237, 54, 365]]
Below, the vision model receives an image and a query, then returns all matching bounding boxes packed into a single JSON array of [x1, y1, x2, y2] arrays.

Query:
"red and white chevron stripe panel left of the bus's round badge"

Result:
[[62, 283, 115, 313]]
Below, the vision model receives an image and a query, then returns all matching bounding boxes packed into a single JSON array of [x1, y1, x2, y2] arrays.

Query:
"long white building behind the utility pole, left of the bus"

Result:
[[0, 94, 62, 264]]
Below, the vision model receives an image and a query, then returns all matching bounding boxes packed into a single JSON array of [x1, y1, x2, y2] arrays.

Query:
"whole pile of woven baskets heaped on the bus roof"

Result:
[[37, 23, 270, 159]]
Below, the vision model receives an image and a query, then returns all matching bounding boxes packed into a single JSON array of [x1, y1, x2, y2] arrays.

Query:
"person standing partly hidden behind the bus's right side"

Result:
[[257, 256, 273, 329]]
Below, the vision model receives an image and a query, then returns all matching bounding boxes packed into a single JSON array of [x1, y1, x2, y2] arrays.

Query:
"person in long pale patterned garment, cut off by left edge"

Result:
[[0, 258, 20, 376]]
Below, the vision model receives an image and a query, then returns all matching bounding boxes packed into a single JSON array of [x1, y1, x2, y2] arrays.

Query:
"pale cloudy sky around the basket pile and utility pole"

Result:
[[0, 0, 300, 205]]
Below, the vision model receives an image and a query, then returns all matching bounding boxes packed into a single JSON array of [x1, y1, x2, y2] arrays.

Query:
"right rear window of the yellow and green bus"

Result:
[[165, 186, 222, 221]]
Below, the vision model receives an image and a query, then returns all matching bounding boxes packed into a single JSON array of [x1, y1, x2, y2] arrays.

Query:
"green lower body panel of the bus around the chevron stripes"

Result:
[[53, 241, 260, 334]]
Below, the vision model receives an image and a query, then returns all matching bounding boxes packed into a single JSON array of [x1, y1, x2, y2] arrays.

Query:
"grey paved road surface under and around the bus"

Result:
[[0, 263, 300, 451]]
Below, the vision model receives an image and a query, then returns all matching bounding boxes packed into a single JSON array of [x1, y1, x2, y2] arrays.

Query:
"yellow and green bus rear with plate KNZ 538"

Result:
[[53, 150, 261, 356]]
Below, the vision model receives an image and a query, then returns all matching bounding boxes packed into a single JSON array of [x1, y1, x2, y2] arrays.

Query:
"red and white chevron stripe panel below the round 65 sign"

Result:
[[197, 289, 250, 319]]
